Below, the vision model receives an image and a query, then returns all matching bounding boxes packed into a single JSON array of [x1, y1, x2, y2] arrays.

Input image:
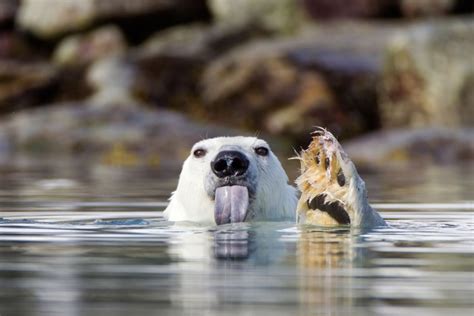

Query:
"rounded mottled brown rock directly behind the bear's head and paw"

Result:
[[202, 52, 344, 135]]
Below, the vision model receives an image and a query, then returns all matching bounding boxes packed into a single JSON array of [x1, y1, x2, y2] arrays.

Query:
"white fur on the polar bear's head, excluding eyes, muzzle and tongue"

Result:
[[164, 136, 297, 224]]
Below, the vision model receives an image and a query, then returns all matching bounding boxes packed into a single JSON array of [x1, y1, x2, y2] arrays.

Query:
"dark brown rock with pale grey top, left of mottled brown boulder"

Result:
[[130, 24, 268, 110]]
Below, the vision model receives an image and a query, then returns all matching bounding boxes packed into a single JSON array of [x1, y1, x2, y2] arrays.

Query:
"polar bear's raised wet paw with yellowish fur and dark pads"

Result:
[[296, 128, 383, 226]]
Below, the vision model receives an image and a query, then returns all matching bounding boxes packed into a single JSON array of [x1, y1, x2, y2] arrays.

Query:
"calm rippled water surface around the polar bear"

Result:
[[0, 158, 474, 316]]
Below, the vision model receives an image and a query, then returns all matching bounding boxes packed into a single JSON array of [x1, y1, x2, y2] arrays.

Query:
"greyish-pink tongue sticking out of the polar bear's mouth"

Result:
[[214, 185, 249, 225]]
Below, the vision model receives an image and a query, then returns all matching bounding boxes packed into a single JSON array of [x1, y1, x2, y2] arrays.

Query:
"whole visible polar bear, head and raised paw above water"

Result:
[[165, 128, 385, 228]]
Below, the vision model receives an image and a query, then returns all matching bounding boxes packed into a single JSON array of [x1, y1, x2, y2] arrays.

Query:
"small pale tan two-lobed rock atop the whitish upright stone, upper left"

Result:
[[53, 25, 127, 65]]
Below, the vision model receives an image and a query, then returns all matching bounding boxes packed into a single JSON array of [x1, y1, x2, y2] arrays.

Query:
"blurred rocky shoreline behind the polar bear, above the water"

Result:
[[0, 0, 474, 165]]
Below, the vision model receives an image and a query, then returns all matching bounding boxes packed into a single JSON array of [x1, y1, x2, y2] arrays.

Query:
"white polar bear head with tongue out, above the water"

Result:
[[165, 136, 297, 224]]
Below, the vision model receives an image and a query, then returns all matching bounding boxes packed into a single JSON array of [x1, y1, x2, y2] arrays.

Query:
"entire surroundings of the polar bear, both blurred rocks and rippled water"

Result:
[[0, 0, 474, 316]]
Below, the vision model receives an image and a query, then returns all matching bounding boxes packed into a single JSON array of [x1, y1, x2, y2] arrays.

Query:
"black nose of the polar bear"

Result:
[[211, 150, 249, 178]]
